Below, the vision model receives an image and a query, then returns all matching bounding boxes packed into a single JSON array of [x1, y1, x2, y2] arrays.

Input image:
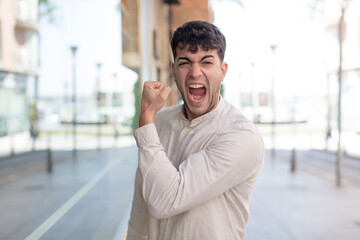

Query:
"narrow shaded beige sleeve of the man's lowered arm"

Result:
[[126, 168, 149, 240]]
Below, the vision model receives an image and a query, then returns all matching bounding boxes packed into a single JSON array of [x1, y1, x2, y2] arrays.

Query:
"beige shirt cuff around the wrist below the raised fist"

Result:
[[134, 123, 160, 148]]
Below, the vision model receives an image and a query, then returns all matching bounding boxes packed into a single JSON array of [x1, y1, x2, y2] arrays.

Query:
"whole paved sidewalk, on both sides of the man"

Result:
[[0, 138, 360, 240]]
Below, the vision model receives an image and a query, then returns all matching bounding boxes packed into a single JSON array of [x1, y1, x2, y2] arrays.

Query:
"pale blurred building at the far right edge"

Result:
[[324, 0, 360, 134]]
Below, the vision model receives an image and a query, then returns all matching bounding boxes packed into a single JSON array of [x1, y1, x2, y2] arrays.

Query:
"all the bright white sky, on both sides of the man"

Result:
[[39, 0, 334, 112]]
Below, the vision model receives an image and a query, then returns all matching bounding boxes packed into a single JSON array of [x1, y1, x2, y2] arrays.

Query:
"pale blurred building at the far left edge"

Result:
[[0, 0, 38, 136]]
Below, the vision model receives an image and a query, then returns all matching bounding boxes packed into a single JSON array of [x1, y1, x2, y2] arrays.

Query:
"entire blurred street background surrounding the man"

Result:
[[0, 0, 360, 239]]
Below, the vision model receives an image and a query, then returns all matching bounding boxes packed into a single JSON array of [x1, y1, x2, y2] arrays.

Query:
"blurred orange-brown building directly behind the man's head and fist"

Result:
[[121, 0, 213, 113]]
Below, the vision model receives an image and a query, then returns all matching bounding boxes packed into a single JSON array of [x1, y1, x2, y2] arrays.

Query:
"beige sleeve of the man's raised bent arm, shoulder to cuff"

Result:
[[134, 124, 264, 219]]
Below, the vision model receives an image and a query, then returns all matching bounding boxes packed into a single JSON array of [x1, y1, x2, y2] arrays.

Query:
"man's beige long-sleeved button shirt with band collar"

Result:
[[127, 98, 264, 240]]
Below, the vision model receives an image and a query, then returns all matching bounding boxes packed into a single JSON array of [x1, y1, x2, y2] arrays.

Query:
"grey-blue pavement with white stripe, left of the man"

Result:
[[0, 141, 137, 240]]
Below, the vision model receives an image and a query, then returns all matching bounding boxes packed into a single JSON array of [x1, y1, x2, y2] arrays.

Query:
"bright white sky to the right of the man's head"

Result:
[[210, 0, 332, 108]]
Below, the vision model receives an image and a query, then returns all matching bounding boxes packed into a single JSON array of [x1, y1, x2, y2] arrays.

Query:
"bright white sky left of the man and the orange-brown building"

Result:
[[39, 0, 137, 97]]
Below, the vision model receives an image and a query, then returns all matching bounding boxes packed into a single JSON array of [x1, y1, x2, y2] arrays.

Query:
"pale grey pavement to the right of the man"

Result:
[[245, 152, 360, 240]]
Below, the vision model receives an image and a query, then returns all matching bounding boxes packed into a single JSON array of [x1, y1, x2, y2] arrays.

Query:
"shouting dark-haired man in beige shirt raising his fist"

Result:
[[127, 21, 264, 240]]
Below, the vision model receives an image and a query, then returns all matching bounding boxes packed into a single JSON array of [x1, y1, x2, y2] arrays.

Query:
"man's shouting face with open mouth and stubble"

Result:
[[172, 47, 227, 121]]
